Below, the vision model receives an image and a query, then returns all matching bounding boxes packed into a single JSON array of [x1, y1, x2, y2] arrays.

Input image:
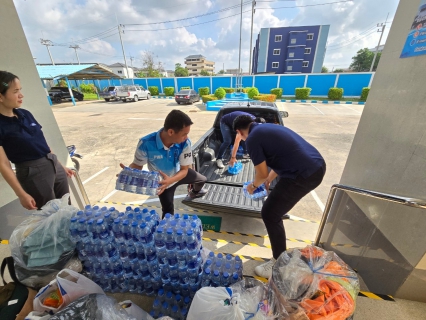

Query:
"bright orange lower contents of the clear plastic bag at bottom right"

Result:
[[300, 279, 355, 320]]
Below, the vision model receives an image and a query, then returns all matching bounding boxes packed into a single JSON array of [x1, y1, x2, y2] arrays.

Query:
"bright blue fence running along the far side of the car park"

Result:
[[70, 72, 374, 97]]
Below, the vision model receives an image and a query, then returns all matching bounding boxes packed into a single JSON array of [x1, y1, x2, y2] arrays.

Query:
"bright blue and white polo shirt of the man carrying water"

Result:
[[133, 129, 192, 177]]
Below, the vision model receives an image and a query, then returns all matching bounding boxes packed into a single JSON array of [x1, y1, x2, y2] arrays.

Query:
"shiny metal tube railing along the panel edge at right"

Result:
[[315, 184, 426, 245]]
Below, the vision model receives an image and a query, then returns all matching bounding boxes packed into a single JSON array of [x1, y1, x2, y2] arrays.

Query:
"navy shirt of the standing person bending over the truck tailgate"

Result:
[[246, 123, 325, 179]]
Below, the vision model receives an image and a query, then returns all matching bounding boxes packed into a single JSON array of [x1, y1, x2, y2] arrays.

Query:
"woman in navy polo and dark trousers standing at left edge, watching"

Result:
[[0, 71, 73, 210]]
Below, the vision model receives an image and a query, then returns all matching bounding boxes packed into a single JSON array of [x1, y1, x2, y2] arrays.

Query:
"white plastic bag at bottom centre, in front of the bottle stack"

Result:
[[187, 287, 244, 320]]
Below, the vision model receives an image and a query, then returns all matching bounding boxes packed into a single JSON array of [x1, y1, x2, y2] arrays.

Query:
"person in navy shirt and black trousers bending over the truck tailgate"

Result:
[[234, 116, 326, 278]]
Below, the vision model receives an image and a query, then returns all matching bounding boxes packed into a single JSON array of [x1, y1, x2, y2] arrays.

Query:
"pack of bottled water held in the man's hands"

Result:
[[115, 167, 161, 196]]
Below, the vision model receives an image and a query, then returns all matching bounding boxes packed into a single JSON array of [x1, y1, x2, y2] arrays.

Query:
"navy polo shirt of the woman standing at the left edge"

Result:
[[0, 109, 50, 163]]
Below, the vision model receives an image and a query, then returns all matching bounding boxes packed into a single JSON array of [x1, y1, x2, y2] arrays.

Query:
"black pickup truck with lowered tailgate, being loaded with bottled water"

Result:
[[182, 101, 288, 217]]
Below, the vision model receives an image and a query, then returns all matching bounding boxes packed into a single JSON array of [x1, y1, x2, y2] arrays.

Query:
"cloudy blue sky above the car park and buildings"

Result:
[[14, 0, 400, 72]]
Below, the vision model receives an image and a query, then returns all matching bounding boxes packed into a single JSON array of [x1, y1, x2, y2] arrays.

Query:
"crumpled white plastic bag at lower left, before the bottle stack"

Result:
[[34, 269, 105, 314]]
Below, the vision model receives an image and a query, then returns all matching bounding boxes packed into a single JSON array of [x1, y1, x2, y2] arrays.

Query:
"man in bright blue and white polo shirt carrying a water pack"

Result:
[[120, 110, 207, 217]]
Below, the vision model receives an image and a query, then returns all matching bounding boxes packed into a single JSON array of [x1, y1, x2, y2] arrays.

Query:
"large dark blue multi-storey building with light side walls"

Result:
[[252, 25, 330, 74]]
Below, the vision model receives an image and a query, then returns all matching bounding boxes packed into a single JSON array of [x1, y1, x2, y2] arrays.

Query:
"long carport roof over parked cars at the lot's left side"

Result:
[[37, 64, 120, 80]]
